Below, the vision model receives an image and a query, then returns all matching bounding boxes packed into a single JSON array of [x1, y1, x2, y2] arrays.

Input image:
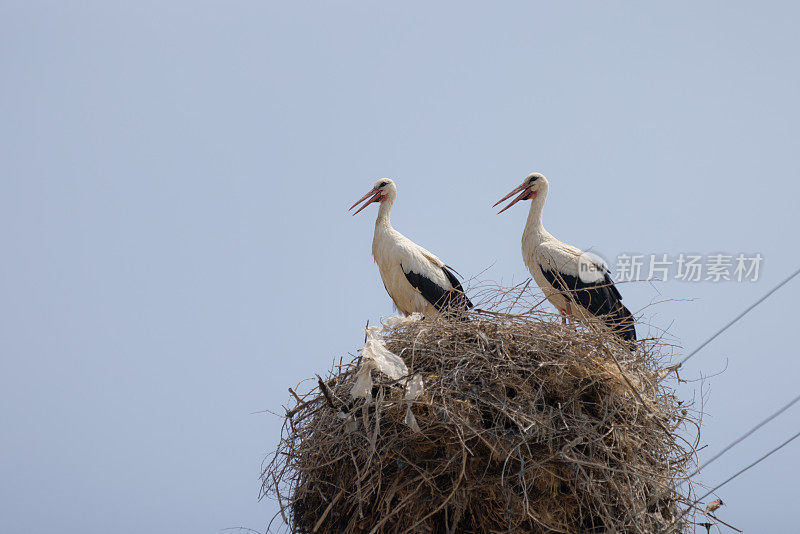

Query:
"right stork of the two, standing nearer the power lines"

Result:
[[495, 172, 636, 341]]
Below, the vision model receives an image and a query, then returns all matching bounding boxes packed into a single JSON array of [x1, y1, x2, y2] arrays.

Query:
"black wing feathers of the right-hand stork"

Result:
[[542, 267, 636, 341]]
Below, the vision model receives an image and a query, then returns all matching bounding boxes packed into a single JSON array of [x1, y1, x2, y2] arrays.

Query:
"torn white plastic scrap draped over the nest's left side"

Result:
[[350, 313, 424, 432]]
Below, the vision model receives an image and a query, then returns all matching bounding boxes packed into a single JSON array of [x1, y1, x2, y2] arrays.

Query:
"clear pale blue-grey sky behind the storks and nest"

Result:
[[0, 0, 800, 534]]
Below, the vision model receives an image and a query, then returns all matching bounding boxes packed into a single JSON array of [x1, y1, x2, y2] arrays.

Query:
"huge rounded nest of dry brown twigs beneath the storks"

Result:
[[262, 286, 696, 533]]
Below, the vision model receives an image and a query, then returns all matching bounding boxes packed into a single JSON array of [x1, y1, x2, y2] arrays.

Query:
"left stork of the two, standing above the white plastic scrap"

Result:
[[348, 178, 472, 316]]
